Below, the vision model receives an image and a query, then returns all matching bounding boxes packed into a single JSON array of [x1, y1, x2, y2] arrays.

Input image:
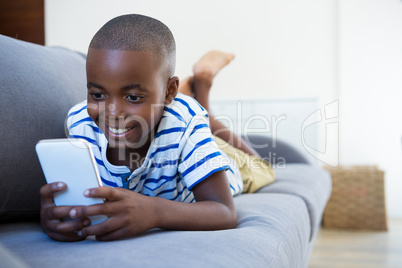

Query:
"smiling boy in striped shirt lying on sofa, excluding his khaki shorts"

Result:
[[41, 15, 272, 241]]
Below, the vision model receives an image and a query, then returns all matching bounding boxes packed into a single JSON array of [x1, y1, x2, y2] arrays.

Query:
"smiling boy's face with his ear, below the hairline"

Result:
[[87, 48, 178, 148]]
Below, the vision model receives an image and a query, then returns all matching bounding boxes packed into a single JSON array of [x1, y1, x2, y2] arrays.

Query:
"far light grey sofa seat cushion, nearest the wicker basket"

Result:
[[257, 164, 332, 239]]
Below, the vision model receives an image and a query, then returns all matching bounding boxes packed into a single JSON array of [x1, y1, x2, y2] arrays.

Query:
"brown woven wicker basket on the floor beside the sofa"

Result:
[[323, 166, 388, 230]]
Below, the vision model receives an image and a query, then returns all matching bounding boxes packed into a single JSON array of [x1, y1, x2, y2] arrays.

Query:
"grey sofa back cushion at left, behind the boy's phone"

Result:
[[0, 35, 86, 223]]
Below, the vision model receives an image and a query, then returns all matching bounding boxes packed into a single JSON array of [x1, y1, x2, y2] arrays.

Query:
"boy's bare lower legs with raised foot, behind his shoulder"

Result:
[[179, 51, 259, 156]]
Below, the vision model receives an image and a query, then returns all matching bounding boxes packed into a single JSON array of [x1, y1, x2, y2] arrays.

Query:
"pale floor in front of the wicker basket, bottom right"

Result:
[[309, 219, 402, 268]]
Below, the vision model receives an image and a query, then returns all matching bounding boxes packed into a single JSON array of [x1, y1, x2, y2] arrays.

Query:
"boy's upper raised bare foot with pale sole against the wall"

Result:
[[193, 50, 235, 84]]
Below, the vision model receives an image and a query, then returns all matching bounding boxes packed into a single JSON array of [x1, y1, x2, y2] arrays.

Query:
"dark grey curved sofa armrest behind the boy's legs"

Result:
[[242, 135, 311, 165]]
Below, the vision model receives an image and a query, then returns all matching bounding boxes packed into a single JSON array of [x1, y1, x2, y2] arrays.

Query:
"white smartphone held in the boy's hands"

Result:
[[35, 139, 107, 224]]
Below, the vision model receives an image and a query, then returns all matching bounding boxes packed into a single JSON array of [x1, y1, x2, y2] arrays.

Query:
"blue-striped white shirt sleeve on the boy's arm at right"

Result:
[[178, 114, 229, 190]]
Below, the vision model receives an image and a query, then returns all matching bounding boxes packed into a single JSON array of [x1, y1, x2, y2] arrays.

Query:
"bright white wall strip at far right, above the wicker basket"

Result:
[[339, 0, 402, 218]]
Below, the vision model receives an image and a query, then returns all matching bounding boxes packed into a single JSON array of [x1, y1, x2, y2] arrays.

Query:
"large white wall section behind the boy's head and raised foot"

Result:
[[45, 0, 336, 102]]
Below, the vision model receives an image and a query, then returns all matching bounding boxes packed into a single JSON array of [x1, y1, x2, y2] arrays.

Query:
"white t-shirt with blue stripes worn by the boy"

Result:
[[67, 93, 243, 202]]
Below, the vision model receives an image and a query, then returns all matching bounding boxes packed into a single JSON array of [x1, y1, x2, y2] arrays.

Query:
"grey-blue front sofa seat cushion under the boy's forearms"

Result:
[[0, 194, 310, 267]]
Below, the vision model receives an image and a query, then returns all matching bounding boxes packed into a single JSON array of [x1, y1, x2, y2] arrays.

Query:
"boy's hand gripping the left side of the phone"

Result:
[[40, 182, 91, 242]]
